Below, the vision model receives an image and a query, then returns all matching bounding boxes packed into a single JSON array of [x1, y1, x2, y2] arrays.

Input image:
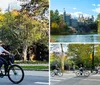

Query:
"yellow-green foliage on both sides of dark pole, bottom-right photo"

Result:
[[68, 44, 100, 68]]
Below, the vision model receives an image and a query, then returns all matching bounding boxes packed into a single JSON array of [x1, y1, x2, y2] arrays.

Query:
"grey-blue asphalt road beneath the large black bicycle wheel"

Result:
[[0, 71, 49, 85]]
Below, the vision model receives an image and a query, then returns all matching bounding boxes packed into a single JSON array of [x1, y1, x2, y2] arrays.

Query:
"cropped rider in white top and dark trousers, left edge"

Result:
[[0, 41, 10, 73]]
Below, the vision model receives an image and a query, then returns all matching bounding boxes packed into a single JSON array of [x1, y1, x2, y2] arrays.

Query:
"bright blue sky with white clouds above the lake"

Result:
[[50, 0, 100, 19]]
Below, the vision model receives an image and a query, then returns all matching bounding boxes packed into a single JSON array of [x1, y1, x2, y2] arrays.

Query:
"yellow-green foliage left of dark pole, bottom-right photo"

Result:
[[68, 44, 93, 67]]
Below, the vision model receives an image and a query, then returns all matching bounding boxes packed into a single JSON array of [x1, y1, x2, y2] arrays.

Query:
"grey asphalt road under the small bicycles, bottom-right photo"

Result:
[[50, 73, 100, 85]]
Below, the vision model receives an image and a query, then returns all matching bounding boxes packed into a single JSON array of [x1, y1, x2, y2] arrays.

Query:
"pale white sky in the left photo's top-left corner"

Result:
[[0, 0, 29, 12]]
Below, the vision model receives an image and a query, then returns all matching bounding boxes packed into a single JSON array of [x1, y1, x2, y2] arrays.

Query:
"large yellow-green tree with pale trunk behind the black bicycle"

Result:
[[0, 0, 49, 60]]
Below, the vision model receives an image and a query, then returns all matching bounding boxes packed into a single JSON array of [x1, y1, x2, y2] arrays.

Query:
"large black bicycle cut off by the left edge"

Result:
[[0, 55, 24, 84]]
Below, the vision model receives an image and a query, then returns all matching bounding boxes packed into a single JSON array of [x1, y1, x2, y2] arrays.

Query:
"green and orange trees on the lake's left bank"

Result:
[[50, 10, 69, 34]]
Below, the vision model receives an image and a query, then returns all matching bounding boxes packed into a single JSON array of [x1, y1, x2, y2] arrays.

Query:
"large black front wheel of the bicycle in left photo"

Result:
[[8, 65, 24, 84]]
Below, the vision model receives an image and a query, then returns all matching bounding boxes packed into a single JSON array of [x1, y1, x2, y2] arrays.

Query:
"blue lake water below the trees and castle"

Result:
[[51, 34, 100, 42]]
